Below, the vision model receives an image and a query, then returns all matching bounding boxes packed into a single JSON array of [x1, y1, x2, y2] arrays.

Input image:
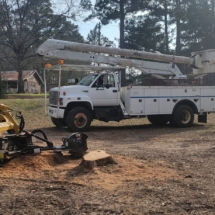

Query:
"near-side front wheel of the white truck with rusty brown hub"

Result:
[[66, 107, 91, 132]]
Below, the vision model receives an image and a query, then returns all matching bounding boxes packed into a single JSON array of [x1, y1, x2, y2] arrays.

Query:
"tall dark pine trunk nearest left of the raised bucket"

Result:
[[176, 0, 181, 55]]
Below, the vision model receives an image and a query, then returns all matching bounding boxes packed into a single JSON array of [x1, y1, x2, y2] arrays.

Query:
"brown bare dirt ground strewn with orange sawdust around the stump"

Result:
[[0, 111, 215, 215]]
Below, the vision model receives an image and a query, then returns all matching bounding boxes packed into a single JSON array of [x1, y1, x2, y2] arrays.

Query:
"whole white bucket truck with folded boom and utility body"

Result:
[[37, 39, 215, 131]]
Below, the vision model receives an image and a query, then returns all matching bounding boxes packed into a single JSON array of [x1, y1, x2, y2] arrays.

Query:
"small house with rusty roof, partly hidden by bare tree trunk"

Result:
[[0, 70, 44, 93]]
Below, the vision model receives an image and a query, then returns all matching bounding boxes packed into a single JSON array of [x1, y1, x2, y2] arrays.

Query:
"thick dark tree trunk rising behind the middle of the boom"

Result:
[[119, 0, 125, 48]]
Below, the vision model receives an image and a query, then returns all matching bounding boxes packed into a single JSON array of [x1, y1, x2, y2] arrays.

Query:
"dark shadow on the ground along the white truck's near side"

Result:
[[29, 124, 212, 144]]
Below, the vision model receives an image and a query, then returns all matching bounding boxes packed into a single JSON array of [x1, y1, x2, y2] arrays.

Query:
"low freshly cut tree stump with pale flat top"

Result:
[[81, 150, 116, 169]]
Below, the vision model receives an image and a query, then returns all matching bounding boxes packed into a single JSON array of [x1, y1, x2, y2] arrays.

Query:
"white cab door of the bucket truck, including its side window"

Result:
[[89, 74, 120, 106]]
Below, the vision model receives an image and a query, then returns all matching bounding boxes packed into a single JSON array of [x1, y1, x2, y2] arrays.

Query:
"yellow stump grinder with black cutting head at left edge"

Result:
[[0, 104, 88, 165]]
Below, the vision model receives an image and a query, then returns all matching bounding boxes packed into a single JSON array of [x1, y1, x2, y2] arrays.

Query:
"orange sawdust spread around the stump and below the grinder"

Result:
[[1, 152, 181, 190]]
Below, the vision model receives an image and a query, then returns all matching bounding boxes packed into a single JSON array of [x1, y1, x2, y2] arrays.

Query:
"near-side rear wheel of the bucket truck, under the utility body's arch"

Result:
[[172, 105, 194, 128]]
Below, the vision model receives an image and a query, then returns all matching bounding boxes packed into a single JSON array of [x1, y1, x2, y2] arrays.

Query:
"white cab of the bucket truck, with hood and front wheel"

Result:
[[48, 72, 122, 131]]
